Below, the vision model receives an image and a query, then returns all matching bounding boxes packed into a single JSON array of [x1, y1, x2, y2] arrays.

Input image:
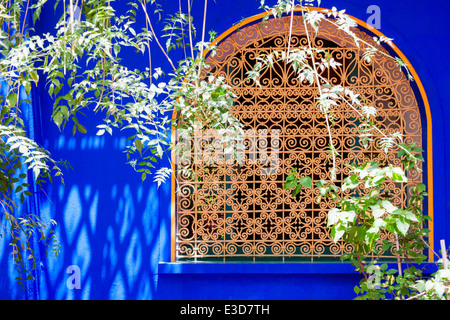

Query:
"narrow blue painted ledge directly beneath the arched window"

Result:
[[158, 262, 437, 274]]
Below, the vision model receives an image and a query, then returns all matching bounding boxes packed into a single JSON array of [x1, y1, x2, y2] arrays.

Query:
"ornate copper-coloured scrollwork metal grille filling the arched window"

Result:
[[176, 16, 422, 261]]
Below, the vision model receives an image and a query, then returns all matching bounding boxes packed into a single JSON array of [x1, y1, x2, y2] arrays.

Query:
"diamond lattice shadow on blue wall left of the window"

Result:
[[35, 124, 159, 300]]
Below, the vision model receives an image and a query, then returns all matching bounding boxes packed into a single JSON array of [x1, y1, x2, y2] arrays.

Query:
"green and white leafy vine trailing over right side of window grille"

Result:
[[258, 0, 450, 299]]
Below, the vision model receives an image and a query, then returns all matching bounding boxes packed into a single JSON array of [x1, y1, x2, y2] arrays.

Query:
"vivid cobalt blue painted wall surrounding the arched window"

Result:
[[0, 0, 450, 299]]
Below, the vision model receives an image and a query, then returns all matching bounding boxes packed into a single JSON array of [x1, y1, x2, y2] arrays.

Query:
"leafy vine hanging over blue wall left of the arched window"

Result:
[[0, 0, 242, 283]]
